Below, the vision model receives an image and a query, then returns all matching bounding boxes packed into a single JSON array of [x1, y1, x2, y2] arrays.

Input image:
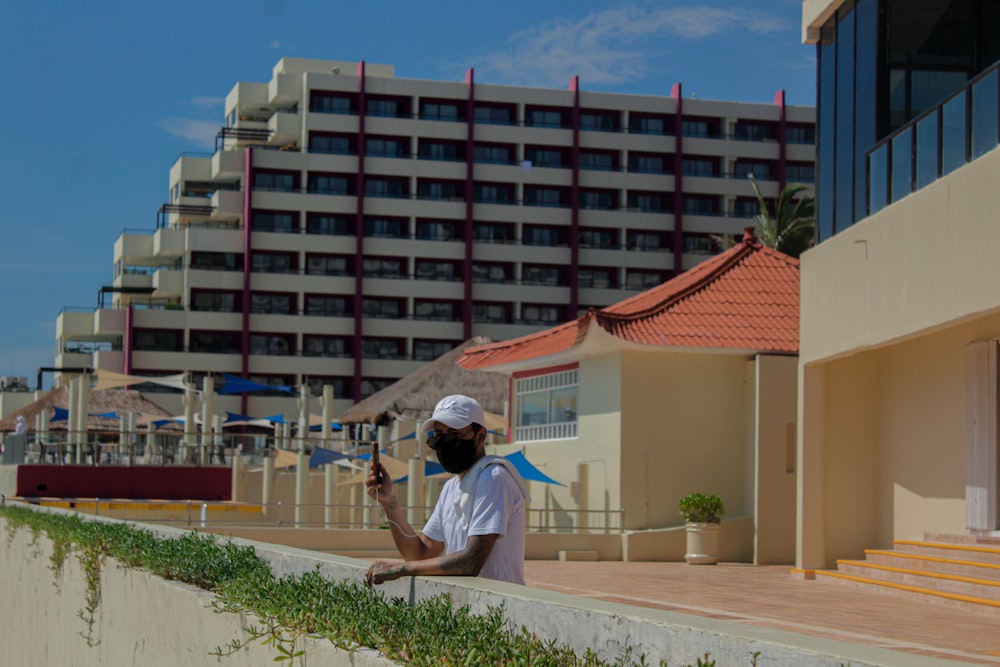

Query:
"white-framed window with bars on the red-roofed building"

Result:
[[514, 368, 579, 442]]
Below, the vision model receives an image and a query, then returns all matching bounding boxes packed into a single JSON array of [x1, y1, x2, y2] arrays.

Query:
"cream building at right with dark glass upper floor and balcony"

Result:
[[796, 0, 1000, 568]]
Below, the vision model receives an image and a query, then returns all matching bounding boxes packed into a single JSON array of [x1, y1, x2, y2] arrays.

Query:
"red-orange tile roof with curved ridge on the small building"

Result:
[[457, 234, 799, 369]]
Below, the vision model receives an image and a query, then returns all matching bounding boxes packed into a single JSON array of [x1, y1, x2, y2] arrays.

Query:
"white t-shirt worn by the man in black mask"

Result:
[[423, 465, 525, 584]]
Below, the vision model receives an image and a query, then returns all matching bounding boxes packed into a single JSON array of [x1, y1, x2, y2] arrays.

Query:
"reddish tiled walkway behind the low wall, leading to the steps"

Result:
[[525, 561, 1000, 665]]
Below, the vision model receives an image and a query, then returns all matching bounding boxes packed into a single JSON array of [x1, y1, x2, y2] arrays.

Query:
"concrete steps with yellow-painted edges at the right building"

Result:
[[815, 535, 1000, 616]]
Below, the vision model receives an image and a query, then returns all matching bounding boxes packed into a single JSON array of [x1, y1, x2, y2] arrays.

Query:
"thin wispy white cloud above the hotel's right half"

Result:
[[476, 5, 789, 86]]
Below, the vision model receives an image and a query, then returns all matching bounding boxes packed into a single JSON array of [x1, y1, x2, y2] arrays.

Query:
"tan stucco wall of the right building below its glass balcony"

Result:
[[796, 150, 1000, 567]]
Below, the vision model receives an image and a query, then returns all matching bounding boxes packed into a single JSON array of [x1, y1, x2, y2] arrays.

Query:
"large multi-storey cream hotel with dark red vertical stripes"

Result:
[[56, 58, 815, 414]]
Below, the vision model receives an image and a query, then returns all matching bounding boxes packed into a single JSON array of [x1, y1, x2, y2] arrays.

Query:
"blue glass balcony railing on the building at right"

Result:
[[868, 62, 1000, 215]]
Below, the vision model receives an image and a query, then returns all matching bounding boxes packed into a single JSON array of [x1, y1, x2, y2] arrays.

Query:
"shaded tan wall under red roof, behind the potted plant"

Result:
[[621, 351, 752, 529]]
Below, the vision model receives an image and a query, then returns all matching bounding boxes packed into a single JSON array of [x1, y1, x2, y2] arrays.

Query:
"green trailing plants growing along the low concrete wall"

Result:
[[0, 501, 759, 667]]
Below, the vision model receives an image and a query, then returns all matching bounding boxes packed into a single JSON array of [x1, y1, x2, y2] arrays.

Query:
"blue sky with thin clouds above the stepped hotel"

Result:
[[0, 0, 815, 387]]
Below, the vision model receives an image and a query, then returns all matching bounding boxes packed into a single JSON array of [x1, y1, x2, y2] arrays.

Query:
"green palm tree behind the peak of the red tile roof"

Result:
[[747, 174, 816, 258]]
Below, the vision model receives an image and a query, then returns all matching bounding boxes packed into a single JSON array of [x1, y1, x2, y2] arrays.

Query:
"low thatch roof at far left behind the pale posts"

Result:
[[0, 386, 172, 432]]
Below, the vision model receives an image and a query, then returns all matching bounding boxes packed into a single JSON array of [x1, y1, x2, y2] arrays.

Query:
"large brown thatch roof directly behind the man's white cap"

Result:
[[340, 336, 510, 424]]
